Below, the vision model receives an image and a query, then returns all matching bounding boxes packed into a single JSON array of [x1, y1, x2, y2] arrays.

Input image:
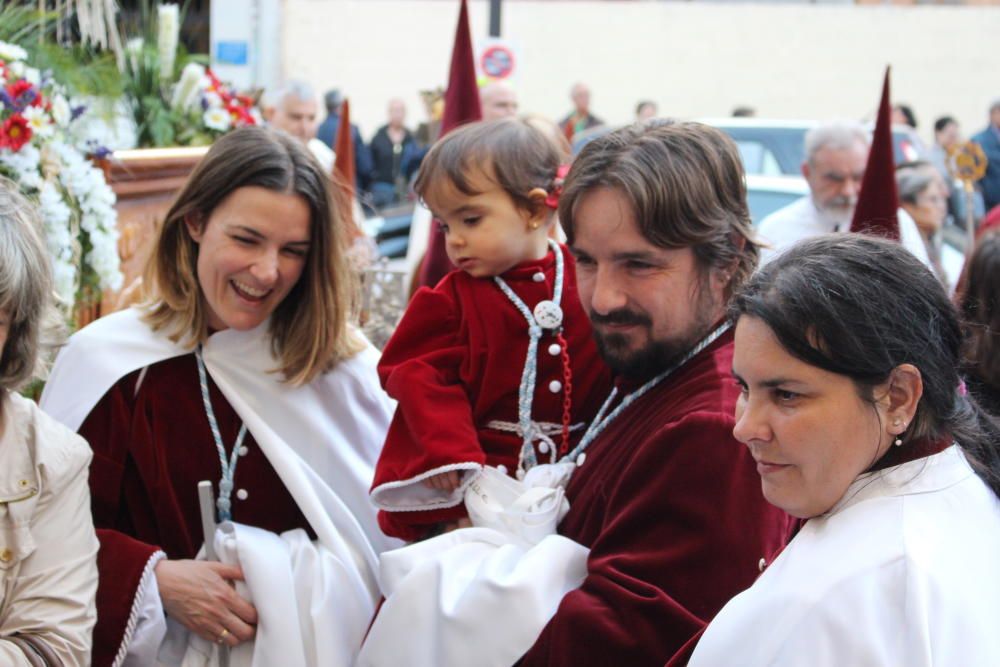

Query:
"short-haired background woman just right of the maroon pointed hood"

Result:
[[896, 161, 957, 292]]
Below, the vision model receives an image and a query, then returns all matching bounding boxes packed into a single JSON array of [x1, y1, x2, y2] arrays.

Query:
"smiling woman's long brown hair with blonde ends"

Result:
[[144, 127, 364, 385]]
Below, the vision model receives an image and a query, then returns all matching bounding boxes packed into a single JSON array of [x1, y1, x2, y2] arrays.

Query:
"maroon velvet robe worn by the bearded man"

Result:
[[520, 331, 790, 667]]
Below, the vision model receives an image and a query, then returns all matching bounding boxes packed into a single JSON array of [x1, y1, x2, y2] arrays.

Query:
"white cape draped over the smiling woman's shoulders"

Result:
[[41, 308, 398, 665]]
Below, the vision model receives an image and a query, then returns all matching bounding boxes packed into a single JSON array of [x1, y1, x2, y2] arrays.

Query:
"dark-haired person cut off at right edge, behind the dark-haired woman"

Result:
[[959, 231, 1000, 414]]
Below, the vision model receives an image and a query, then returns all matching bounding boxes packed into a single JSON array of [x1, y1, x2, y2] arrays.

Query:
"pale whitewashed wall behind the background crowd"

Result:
[[282, 0, 1000, 146]]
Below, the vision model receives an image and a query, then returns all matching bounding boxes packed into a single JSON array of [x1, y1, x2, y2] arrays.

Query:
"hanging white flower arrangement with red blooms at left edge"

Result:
[[0, 42, 122, 313]]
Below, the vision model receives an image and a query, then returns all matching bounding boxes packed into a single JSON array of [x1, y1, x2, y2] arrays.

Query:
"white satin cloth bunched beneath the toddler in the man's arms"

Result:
[[357, 464, 589, 667]]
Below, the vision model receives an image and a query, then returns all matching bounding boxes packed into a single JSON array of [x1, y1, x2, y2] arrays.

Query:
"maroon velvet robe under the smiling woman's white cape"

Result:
[[79, 354, 310, 666]]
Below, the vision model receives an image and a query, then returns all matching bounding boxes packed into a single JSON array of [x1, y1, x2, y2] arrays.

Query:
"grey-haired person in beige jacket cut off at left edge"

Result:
[[0, 181, 97, 667]]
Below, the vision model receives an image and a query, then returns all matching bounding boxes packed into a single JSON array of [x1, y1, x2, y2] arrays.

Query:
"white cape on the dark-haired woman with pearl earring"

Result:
[[689, 446, 1000, 667]]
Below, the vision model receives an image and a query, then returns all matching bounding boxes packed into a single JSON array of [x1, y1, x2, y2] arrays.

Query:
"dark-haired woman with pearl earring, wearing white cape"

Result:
[[690, 236, 1000, 667]]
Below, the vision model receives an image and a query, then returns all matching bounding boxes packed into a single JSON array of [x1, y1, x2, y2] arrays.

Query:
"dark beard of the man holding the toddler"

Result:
[[590, 289, 719, 382]]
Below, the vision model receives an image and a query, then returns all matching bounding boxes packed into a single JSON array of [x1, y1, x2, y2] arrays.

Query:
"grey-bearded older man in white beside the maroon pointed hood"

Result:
[[759, 122, 930, 266]]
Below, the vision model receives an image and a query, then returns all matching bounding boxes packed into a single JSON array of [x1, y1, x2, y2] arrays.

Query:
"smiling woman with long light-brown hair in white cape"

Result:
[[42, 127, 391, 665]]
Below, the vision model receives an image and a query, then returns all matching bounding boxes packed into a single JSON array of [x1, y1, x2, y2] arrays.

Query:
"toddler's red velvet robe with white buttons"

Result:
[[372, 249, 610, 540]]
